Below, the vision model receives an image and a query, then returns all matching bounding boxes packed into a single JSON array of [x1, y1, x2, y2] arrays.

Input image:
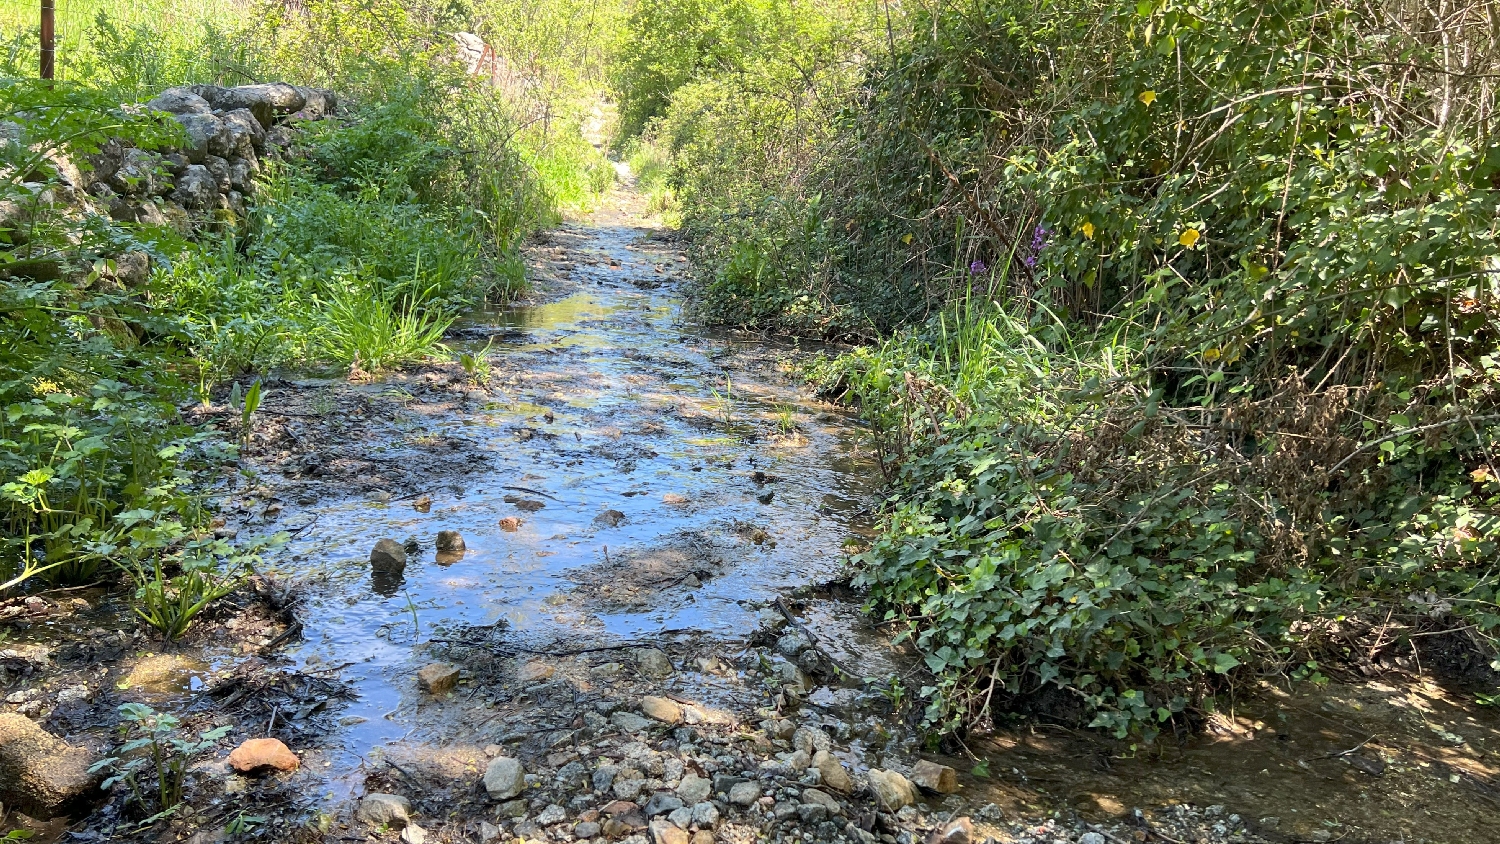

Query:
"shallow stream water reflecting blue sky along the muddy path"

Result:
[[261, 215, 875, 796]]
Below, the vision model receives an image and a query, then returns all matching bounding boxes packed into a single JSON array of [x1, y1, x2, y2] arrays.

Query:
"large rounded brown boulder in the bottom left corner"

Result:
[[0, 714, 98, 819]]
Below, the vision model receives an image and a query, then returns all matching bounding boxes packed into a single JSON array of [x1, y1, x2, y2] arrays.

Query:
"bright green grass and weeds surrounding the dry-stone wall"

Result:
[[0, 0, 612, 626]]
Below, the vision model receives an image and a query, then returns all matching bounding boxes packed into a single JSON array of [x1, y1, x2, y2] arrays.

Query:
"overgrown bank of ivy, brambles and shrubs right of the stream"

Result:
[[626, 0, 1500, 735]]
